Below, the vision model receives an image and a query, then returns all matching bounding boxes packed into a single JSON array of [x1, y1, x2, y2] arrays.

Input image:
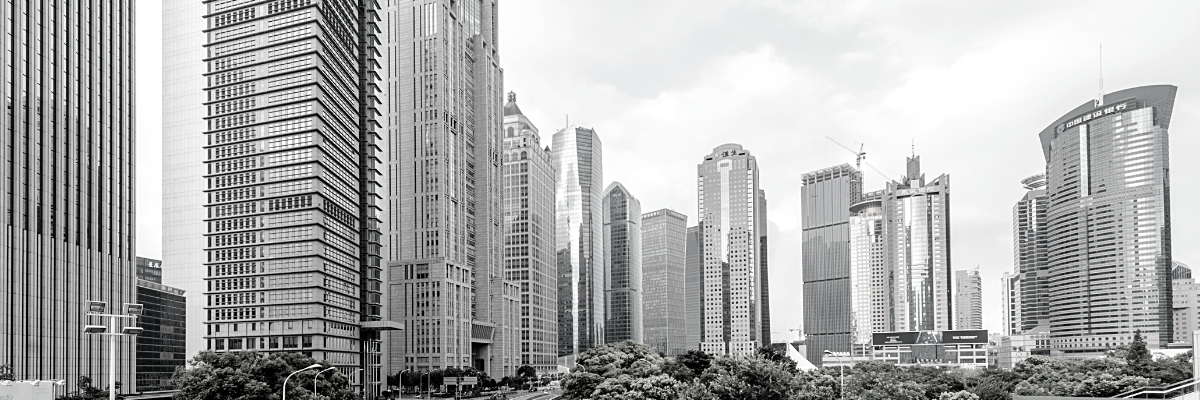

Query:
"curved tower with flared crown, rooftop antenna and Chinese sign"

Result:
[[1038, 85, 1177, 357]]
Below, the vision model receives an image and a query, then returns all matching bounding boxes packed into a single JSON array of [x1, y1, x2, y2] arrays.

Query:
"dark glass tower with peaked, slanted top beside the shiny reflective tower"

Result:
[[602, 181, 643, 344]]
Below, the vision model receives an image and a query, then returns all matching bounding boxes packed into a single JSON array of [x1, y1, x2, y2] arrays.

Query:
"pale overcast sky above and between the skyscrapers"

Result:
[[137, 0, 1200, 334]]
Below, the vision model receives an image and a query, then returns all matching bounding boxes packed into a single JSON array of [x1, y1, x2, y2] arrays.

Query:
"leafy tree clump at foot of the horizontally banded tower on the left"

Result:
[[172, 352, 355, 400]]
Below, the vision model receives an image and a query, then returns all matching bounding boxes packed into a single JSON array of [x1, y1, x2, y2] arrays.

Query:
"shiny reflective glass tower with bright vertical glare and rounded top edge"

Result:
[[551, 126, 605, 355]]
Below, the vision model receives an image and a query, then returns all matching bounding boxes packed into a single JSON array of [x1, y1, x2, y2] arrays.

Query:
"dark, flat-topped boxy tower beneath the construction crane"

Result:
[[800, 163, 863, 365]]
